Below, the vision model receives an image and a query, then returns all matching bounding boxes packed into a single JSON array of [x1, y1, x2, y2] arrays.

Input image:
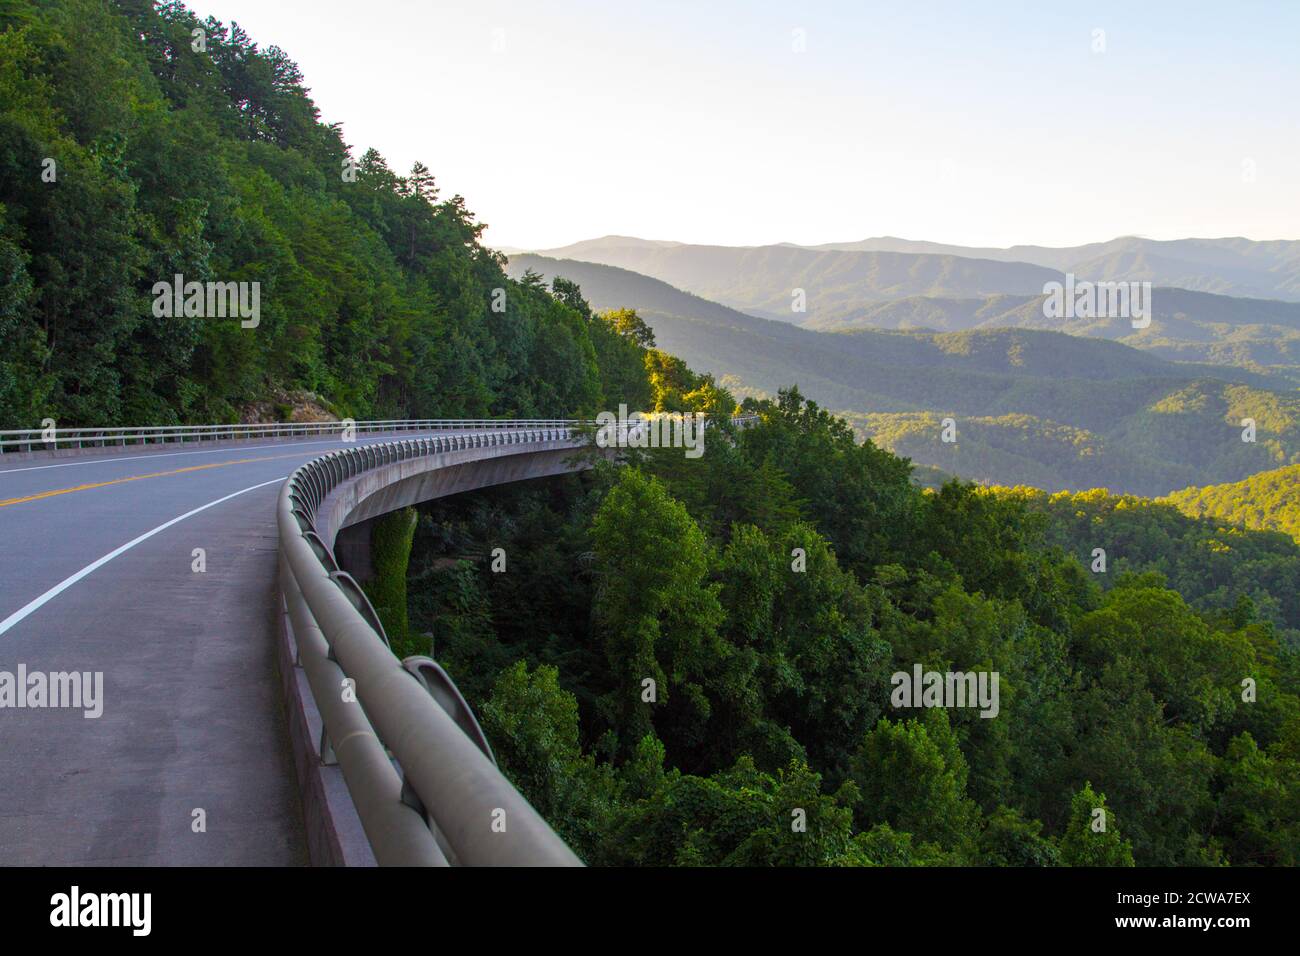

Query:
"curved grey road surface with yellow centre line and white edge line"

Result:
[[0, 431, 478, 865]]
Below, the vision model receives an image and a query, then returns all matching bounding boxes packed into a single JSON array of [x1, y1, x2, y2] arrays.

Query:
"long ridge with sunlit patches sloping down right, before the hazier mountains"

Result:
[[507, 255, 1300, 494]]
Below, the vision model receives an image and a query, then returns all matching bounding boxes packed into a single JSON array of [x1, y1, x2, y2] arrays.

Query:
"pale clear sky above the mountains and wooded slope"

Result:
[[191, 0, 1300, 250]]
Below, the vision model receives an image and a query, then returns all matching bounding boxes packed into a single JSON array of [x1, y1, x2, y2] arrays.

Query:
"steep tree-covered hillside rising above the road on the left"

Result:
[[0, 0, 645, 428]]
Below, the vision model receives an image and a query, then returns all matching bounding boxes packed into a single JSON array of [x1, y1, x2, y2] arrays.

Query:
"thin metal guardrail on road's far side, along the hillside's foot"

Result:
[[0, 419, 571, 454]]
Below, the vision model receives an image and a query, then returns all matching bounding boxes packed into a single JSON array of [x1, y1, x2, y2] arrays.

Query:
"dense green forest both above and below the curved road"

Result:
[[0, 0, 1300, 866]]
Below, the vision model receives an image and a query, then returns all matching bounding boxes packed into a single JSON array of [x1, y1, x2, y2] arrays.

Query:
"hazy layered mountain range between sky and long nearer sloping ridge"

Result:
[[520, 235, 1300, 385]]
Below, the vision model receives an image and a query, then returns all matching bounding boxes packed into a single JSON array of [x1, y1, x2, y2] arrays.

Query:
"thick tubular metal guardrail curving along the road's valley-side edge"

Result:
[[277, 416, 758, 866]]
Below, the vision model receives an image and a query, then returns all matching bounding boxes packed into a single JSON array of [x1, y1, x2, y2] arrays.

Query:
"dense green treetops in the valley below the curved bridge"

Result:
[[403, 390, 1300, 866]]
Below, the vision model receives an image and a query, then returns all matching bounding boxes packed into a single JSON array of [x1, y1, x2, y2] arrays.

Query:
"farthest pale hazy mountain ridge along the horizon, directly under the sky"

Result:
[[541, 235, 1300, 308]]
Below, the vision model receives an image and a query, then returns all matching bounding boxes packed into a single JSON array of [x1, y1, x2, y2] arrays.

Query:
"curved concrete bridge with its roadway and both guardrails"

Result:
[[0, 421, 621, 865]]
